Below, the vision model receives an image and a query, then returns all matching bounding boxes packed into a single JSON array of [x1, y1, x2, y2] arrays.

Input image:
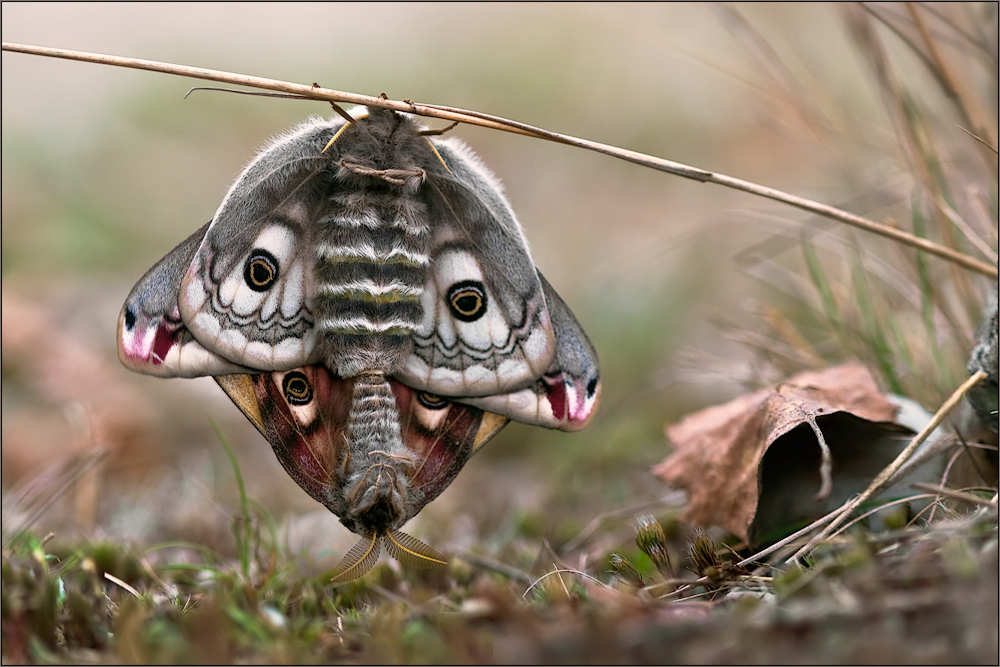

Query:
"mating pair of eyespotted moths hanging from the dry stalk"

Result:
[[118, 107, 601, 580]]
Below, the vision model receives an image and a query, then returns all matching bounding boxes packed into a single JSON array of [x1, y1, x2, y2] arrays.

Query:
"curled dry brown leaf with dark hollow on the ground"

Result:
[[653, 363, 907, 542]]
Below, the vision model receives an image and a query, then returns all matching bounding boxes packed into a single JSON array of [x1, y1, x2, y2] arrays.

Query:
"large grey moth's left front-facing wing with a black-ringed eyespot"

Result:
[[179, 119, 352, 371]]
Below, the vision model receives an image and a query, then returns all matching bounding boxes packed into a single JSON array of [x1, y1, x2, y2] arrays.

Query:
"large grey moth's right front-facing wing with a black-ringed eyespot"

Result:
[[397, 140, 556, 397]]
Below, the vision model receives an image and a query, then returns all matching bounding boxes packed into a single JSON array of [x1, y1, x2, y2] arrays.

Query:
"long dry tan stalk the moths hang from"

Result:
[[3, 42, 998, 278]]
